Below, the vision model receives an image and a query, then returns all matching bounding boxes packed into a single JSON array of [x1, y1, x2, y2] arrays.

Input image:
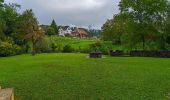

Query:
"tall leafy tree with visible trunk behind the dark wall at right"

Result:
[[119, 0, 167, 49]]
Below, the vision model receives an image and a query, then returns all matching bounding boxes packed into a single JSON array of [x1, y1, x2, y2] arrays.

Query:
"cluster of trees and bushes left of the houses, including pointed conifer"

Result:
[[0, 0, 58, 56]]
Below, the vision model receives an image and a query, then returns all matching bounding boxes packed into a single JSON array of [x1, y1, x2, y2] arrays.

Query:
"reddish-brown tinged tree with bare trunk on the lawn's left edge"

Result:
[[18, 10, 43, 55]]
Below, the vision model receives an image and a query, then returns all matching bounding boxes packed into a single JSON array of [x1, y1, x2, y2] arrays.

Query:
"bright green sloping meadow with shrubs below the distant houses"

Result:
[[45, 36, 123, 54]]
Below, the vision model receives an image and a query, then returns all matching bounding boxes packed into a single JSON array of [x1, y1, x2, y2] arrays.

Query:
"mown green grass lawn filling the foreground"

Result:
[[0, 54, 170, 100]]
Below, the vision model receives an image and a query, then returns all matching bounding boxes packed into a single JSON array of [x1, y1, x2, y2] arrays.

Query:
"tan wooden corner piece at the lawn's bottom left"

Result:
[[0, 87, 14, 100]]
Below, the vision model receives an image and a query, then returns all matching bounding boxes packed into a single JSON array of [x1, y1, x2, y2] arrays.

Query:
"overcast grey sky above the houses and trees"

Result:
[[5, 0, 120, 28]]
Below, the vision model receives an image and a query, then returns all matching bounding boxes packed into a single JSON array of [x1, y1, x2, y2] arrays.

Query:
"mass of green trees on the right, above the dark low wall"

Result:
[[102, 0, 170, 50]]
